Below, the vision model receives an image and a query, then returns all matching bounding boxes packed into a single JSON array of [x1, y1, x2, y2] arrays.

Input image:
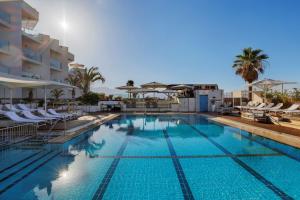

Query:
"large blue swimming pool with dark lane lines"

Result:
[[0, 115, 300, 199]]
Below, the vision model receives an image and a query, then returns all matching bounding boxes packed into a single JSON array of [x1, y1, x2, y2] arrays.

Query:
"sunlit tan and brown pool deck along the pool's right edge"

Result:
[[200, 113, 300, 148]]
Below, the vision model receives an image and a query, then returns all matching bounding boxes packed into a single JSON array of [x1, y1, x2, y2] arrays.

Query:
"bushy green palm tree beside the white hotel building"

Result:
[[75, 67, 105, 95]]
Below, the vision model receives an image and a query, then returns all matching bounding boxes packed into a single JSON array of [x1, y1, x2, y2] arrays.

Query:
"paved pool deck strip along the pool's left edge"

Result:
[[48, 114, 119, 144]]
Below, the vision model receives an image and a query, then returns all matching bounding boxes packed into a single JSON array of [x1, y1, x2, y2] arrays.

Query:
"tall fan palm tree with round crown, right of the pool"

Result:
[[232, 47, 269, 101]]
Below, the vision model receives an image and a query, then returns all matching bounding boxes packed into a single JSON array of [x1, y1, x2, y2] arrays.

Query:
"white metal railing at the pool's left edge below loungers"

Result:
[[0, 124, 37, 146]]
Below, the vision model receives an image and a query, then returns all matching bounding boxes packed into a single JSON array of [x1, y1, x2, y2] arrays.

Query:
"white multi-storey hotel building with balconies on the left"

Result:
[[0, 0, 74, 99]]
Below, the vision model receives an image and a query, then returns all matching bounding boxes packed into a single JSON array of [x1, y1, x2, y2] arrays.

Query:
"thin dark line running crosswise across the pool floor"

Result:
[[92, 153, 283, 159]]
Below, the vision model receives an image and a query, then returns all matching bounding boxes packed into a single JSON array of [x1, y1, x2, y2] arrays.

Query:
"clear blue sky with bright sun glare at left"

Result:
[[27, 0, 300, 91]]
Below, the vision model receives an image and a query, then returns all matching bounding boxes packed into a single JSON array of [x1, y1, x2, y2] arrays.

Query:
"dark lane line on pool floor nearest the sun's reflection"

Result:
[[93, 136, 129, 200]]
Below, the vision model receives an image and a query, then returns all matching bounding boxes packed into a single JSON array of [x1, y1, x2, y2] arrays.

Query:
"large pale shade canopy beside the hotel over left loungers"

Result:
[[0, 73, 76, 89]]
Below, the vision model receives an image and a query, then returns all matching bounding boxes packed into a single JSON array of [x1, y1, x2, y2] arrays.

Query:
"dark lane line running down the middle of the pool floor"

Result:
[[163, 130, 195, 200]]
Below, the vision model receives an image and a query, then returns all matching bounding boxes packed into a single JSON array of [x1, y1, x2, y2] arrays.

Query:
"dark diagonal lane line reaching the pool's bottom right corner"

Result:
[[182, 120, 294, 200]]
